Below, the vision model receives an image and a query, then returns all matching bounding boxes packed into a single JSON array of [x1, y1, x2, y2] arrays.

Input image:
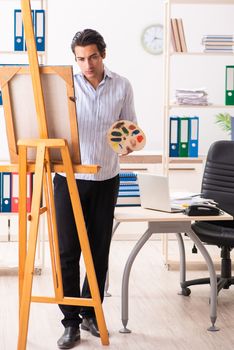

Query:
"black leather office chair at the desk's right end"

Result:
[[181, 141, 234, 295]]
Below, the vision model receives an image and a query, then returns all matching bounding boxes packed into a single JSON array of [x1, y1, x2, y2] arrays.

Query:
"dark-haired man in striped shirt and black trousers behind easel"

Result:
[[54, 29, 136, 349]]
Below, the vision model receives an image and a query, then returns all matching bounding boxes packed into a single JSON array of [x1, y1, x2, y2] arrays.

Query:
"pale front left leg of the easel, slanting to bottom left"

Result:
[[18, 145, 45, 350]]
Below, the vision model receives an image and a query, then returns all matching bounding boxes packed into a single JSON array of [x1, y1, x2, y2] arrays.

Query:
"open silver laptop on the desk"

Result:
[[137, 173, 183, 213]]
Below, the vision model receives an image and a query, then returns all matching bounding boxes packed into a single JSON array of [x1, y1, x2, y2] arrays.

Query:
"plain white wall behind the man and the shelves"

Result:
[[0, 0, 234, 159]]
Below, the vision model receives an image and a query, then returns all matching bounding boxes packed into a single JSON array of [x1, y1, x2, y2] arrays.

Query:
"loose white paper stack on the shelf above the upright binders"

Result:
[[175, 88, 208, 106]]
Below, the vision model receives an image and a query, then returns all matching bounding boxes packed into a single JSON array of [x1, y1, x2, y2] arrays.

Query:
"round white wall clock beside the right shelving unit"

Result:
[[141, 24, 163, 55]]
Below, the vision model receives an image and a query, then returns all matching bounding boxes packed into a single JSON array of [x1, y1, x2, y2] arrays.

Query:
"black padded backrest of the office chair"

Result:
[[201, 140, 234, 215]]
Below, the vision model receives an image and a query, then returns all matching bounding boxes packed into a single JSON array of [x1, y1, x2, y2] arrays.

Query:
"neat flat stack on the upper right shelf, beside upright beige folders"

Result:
[[202, 35, 234, 52]]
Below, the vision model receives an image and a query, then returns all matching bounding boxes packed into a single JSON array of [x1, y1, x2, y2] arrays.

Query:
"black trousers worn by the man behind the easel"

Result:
[[54, 174, 119, 327]]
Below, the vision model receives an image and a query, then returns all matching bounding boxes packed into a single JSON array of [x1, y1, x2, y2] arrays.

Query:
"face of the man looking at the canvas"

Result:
[[75, 44, 105, 80]]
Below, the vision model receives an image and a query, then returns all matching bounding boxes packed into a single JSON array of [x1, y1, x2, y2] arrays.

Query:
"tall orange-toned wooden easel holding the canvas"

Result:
[[18, 0, 109, 350]]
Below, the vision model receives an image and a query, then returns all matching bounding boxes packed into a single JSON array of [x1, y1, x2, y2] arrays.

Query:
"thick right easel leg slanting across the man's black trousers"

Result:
[[61, 146, 109, 345]]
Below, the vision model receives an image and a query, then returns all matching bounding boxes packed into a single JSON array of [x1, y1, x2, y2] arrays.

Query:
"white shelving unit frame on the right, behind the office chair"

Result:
[[162, 0, 234, 265]]
